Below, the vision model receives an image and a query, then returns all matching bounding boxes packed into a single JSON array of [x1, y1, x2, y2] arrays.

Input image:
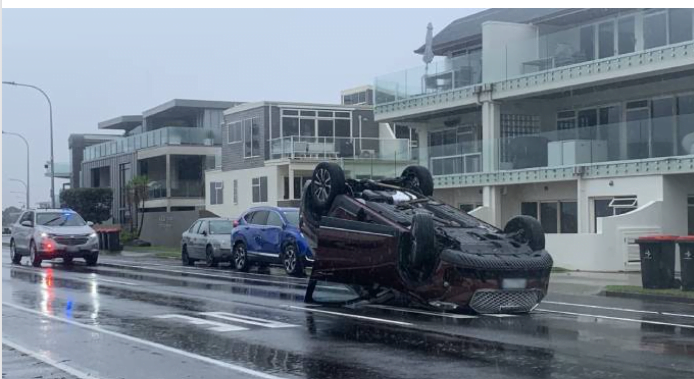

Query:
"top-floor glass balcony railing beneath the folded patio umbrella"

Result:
[[374, 51, 482, 105]]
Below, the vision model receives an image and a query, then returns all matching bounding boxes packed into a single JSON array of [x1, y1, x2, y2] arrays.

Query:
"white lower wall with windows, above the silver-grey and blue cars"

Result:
[[205, 166, 282, 217]]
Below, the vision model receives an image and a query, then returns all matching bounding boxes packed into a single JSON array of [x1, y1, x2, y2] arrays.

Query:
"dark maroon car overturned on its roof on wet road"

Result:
[[300, 162, 552, 313]]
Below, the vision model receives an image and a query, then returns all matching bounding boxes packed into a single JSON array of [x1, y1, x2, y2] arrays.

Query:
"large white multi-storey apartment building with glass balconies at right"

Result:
[[374, 9, 694, 271]]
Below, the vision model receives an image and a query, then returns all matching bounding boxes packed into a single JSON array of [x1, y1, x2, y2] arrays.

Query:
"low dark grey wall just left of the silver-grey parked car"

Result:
[[140, 211, 200, 247]]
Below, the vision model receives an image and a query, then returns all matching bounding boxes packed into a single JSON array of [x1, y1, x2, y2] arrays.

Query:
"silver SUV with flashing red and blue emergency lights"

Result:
[[10, 209, 99, 267]]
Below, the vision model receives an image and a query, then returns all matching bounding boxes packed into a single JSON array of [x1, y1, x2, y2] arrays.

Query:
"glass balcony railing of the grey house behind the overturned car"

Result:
[[270, 136, 412, 161]]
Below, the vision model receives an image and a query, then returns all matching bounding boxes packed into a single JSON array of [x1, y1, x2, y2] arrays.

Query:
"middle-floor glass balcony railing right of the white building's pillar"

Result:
[[498, 115, 694, 170]]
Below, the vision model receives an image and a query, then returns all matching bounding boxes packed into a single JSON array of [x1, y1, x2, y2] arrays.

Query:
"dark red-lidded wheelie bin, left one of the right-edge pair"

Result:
[[636, 235, 679, 289]]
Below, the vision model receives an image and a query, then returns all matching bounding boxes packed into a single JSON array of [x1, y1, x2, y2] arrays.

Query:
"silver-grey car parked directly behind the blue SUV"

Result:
[[181, 218, 232, 267]]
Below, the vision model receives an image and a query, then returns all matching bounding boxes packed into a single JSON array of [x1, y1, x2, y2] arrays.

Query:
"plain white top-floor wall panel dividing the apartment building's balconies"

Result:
[[482, 21, 539, 82]]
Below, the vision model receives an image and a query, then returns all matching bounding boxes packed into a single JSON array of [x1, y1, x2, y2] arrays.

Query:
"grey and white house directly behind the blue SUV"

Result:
[[205, 102, 413, 217]]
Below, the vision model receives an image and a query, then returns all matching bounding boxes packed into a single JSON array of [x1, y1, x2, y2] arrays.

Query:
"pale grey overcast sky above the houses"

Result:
[[2, 9, 476, 211]]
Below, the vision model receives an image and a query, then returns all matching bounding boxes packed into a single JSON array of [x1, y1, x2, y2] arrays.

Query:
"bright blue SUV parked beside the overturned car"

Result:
[[231, 207, 313, 276]]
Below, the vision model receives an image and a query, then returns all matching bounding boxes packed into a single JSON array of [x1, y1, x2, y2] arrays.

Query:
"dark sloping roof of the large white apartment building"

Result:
[[414, 8, 575, 55]]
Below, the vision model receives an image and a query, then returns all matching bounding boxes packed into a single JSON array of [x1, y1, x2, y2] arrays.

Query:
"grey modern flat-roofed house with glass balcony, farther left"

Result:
[[80, 99, 240, 224]]
